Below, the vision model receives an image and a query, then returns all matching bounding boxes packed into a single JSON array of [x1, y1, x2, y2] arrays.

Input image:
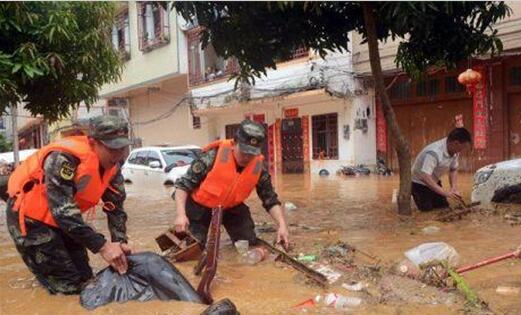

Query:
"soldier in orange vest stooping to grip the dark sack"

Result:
[[6, 116, 130, 294]]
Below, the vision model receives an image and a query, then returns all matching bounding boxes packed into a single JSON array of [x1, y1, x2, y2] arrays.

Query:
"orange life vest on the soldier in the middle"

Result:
[[191, 140, 264, 209]]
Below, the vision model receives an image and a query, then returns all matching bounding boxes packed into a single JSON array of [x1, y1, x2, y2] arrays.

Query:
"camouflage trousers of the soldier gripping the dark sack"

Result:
[[6, 200, 92, 294]]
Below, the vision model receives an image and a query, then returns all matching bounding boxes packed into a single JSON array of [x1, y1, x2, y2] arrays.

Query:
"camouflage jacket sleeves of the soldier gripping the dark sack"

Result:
[[44, 152, 127, 253]]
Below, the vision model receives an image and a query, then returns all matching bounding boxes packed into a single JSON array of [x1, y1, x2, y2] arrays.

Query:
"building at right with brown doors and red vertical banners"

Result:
[[353, 2, 521, 171]]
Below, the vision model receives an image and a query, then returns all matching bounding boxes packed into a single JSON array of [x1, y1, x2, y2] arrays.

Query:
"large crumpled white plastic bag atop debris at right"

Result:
[[405, 242, 459, 267]]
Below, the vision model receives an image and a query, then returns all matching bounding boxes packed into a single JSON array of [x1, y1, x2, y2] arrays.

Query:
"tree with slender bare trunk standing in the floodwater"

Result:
[[174, 1, 510, 214]]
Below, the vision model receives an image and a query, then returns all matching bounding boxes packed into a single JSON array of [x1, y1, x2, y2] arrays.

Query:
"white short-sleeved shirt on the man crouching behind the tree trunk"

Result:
[[412, 138, 459, 185]]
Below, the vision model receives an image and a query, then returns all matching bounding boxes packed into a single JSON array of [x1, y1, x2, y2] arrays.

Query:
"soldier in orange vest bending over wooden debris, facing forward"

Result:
[[173, 120, 289, 246]]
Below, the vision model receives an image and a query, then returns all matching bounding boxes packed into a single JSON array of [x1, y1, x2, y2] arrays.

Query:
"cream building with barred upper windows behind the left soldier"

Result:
[[60, 1, 210, 146]]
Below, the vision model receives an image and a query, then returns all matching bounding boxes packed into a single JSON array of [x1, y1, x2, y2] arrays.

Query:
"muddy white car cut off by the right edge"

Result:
[[471, 159, 521, 208]]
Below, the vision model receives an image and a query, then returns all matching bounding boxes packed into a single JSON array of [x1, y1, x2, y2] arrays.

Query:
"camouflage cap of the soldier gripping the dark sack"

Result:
[[89, 115, 131, 149]]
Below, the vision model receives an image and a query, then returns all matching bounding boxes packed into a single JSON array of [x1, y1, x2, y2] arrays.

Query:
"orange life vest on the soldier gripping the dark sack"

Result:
[[7, 136, 118, 236]]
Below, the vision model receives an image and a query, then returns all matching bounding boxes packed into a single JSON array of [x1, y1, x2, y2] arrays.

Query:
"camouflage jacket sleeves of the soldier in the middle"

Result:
[[172, 149, 281, 211]]
